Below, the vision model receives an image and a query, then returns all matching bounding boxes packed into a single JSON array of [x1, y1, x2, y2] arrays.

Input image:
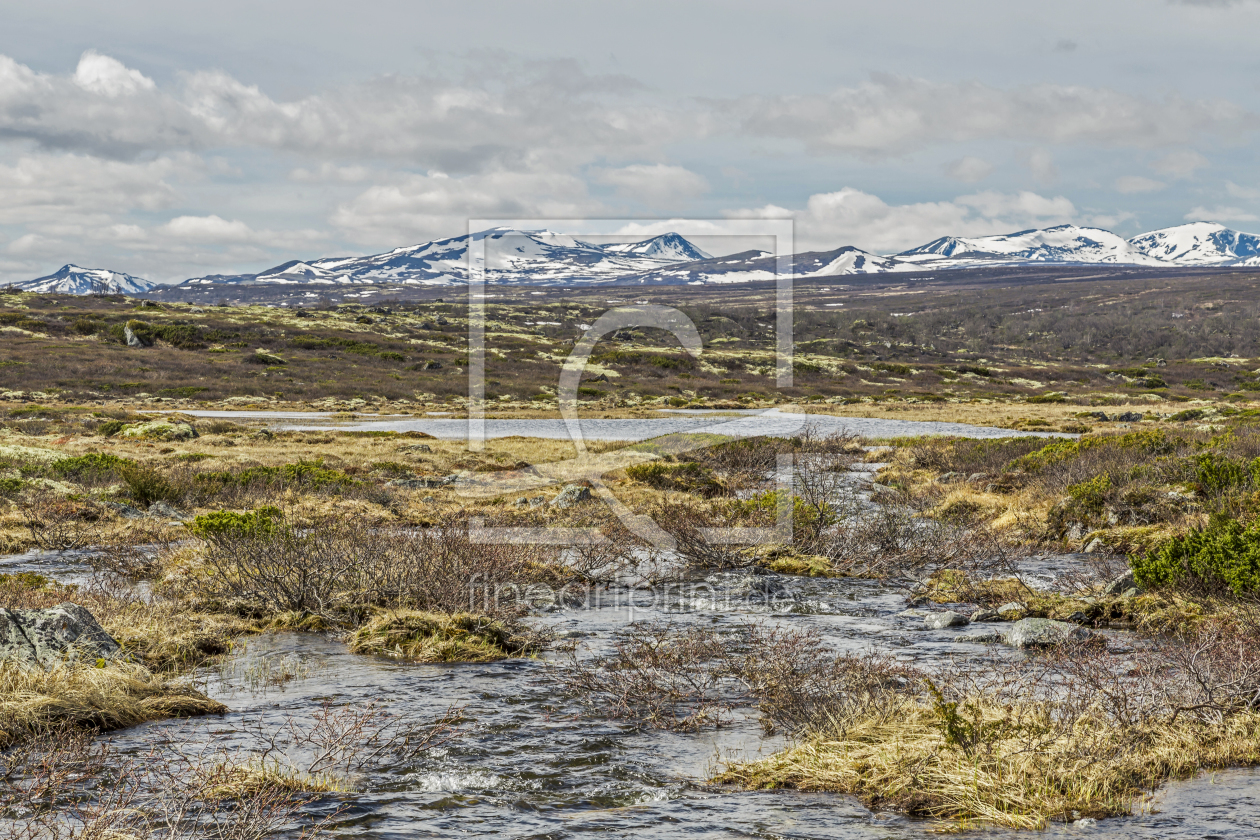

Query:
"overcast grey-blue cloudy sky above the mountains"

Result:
[[0, 0, 1260, 282]]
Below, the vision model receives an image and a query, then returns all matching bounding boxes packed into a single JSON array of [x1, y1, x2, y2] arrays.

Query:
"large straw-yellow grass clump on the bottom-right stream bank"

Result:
[[713, 699, 1260, 829]]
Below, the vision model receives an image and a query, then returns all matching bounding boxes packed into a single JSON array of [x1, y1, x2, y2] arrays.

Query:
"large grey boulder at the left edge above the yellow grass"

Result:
[[0, 603, 122, 667]]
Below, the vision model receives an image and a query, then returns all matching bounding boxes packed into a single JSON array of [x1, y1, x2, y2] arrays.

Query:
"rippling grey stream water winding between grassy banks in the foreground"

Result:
[[0, 416, 1260, 840]]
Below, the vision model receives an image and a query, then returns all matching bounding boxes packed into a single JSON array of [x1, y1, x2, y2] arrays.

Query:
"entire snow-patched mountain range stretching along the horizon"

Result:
[[18, 222, 1260, 295]]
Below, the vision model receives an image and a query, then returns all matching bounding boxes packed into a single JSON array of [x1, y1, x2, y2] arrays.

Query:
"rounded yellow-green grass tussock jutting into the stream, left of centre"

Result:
[[349, 610, 532, 662]]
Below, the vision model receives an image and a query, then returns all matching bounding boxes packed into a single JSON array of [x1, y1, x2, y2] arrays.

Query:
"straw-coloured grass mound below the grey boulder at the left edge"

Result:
[[0, 661, 227, 747]]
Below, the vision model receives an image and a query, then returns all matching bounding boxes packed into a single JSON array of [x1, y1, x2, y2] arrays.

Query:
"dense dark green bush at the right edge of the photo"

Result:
[[1130, 519, 1260, 596]]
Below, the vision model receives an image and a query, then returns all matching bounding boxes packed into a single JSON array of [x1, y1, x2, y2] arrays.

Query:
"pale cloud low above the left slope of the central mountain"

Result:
[[331, 171, 601, 246]]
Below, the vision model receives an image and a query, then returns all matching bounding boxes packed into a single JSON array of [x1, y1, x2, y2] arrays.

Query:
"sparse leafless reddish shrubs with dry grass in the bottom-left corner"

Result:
[[0, 705, 464, 840]]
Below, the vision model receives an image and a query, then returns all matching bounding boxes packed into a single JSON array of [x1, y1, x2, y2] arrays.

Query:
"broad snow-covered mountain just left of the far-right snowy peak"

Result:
[[893, 224, 1163, 267]]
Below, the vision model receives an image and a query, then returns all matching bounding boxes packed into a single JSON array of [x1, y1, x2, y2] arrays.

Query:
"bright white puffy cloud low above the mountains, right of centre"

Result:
[[728, 188, 1077, 253]]
